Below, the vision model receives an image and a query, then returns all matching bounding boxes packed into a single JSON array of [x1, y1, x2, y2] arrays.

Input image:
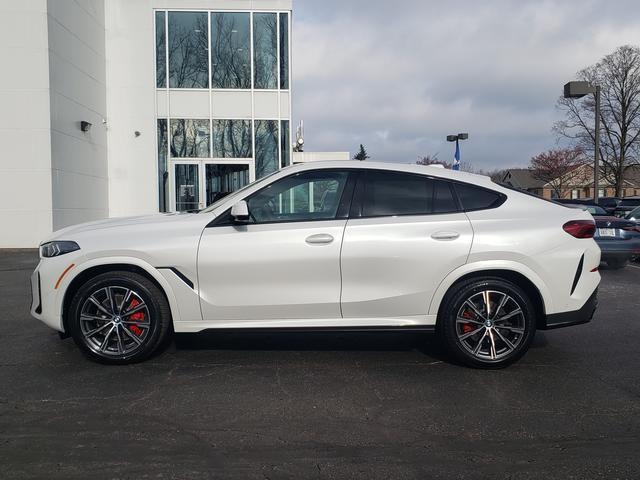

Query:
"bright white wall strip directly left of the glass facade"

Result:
[[105, 0, 158, 217]]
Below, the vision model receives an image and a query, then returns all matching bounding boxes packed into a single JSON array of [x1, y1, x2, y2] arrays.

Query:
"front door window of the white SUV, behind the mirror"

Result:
[[247, 170, 349, 223]]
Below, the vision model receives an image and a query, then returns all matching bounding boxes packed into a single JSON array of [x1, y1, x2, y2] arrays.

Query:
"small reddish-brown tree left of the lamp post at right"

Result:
[[529, 147, 588, 198]]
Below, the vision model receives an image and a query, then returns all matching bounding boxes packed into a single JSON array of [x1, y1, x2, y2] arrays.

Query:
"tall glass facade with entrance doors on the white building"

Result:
[[154, 10, 291, 211]]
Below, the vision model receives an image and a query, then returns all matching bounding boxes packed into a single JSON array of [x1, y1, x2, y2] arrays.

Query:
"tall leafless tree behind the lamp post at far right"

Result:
[[554, 45, 640, 196]]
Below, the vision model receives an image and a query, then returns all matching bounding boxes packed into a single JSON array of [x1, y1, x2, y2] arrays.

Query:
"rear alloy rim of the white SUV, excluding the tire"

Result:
[[456, 290, 526, 361]]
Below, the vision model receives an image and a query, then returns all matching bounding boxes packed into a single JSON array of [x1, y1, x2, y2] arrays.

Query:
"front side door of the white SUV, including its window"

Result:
[[198, 169, 353, 322]]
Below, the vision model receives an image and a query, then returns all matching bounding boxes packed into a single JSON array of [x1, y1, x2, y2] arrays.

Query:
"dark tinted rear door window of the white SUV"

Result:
[[362, 170, 458, 217]]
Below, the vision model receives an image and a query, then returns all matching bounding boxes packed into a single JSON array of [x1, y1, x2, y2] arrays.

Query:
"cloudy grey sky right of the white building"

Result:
[[292, 0, 640, 169]]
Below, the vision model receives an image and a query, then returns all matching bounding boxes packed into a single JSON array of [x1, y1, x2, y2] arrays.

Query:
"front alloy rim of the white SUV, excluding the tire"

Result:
[[80, 285, 152, 357]]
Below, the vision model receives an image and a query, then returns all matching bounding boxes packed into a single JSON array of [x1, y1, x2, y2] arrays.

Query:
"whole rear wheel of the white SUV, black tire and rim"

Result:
[[438, 277, 536, 369]]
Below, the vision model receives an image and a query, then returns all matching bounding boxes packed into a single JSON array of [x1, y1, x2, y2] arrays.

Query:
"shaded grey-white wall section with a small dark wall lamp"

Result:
[[47, 0, 109, 230]]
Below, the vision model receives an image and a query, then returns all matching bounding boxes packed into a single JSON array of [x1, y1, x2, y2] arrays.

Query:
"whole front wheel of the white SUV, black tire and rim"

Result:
[[67, 271, 172, 365]]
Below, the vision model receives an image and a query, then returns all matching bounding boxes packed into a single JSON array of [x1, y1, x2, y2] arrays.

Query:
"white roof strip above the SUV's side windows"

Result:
[[287, 160, 498, 188]]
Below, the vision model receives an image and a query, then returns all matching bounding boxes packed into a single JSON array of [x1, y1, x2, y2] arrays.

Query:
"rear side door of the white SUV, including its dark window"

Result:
[[341, 170, 473, 320]]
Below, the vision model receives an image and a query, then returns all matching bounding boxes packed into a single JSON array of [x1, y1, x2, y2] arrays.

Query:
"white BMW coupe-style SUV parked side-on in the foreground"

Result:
[[31, 162, 600, 368]]
